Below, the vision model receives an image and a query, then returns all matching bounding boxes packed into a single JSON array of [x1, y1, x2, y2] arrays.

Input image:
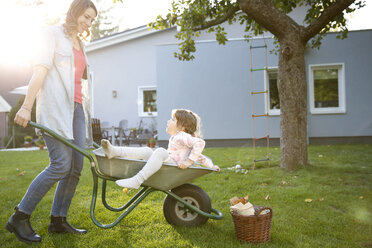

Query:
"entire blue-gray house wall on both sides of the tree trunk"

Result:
[[156, 30, 372, 144]]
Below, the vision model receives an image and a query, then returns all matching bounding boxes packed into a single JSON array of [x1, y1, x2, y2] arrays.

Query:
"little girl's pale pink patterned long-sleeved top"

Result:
[[168, 131, 213, 168]]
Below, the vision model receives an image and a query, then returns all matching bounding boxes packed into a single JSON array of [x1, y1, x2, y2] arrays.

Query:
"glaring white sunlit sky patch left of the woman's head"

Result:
[[0, 1, 67, 66]]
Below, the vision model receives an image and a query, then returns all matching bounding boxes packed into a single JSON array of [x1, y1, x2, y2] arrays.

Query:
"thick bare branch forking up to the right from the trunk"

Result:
[[302, 0, 355, 43]]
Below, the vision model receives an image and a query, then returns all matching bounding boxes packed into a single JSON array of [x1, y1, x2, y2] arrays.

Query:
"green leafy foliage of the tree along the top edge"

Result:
[[147, 0, 365, 60]]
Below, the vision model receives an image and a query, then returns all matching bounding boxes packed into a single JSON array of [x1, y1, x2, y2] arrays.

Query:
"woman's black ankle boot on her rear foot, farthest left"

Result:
[[5, 207, 41, 243]]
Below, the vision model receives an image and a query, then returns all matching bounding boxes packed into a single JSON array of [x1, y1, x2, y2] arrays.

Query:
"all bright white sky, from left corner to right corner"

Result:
[[0, 0, 372, 65]]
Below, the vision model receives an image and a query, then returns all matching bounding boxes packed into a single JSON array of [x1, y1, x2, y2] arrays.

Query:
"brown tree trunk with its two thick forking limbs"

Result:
[[237, 0, 355, 170]]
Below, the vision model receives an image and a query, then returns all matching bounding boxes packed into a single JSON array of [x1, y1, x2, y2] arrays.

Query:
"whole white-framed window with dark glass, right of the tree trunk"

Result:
[[309, 64, 346, 114]]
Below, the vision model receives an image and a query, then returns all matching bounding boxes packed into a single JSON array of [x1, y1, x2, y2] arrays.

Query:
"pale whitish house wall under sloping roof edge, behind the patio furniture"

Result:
[[88, 29, 175, 130]]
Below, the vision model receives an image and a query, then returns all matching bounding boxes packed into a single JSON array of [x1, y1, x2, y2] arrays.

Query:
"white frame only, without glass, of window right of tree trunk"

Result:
[[309, 63, 346, 114]]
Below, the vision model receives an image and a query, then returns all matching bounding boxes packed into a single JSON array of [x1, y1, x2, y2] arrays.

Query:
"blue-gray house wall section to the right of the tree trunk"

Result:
[[306, 30, 372, 139]]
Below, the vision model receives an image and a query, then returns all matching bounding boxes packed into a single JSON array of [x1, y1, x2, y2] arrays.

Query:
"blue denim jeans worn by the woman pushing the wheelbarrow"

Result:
[[18, 103, 86, 217]]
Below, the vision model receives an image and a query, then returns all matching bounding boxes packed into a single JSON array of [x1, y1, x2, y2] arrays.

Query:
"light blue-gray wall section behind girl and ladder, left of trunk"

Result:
[[157, 39, 280, 142]]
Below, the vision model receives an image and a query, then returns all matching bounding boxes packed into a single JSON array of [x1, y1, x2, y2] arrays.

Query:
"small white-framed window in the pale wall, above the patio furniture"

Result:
[[138, 86, 158, 117]]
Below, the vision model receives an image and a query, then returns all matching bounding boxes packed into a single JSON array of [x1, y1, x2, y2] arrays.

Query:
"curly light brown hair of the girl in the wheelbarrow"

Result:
[[172, 109, 203, 138]]
